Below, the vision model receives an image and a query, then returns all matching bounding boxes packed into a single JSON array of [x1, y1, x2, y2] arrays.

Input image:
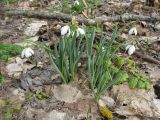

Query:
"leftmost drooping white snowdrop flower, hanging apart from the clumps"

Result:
[[21, 47, 34, 58]]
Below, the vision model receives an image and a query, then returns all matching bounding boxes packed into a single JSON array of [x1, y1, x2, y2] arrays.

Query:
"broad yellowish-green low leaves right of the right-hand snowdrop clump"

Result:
[[112, 56, 152, 90]]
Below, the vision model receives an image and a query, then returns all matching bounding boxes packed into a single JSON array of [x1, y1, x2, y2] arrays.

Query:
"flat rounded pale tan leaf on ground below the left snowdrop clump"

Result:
[[53, 85, 82, 103]]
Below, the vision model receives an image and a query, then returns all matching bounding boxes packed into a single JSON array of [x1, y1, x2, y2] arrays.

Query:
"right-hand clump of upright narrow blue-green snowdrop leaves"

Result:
[[86, 29, 120, 100]]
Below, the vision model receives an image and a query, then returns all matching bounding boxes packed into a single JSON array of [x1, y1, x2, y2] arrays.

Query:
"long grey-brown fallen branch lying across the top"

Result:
[[0, 8, 160, 25]]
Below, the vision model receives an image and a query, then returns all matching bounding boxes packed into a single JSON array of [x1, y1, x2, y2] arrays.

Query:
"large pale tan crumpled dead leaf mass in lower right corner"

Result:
[[111, 85, 160, 119]]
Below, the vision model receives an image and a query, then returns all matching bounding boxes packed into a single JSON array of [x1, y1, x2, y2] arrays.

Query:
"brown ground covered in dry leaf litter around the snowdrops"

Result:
[[0, 0, 160, 120]]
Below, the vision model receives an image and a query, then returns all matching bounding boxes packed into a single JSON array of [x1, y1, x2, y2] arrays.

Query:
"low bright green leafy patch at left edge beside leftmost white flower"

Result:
[[0, 43, 23, 62]]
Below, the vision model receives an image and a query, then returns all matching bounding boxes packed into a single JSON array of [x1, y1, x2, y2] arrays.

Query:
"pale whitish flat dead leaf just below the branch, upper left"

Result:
[[24, 20, 47, 36]]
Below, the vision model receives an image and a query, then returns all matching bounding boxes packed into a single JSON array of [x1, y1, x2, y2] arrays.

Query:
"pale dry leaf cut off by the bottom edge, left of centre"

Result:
[[42, 110, 71, 120]]
